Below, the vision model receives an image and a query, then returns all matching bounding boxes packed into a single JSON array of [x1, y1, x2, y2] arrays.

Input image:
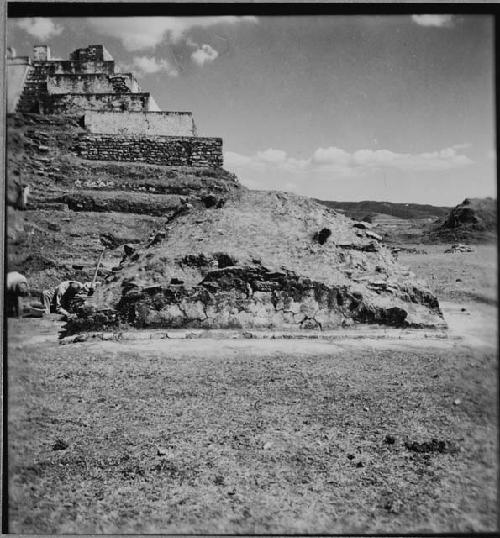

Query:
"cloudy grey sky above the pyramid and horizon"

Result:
[[7, 14, 496, 206]]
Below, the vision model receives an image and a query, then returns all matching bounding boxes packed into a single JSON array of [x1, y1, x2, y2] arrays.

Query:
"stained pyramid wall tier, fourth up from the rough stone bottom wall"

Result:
[[47, 73, 139, 94]]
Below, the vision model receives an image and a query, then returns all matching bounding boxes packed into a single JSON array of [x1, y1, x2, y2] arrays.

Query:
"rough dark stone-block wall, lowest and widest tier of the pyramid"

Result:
[[75, 134, 223, 168]]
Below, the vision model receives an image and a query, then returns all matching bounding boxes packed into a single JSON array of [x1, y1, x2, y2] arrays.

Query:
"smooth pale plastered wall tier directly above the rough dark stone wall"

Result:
[[85, 111, 196, 136]]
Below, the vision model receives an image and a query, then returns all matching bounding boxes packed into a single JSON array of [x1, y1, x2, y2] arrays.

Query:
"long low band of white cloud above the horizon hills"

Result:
[[224, 144, 473, 177]]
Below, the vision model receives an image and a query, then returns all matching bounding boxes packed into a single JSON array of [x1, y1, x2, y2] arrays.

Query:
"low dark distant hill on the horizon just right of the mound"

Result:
[[317, 200, 451, 220]]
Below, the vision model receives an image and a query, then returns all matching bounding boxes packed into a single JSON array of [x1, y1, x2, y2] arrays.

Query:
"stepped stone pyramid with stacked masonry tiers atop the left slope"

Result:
[[7, 45, 223, 168]]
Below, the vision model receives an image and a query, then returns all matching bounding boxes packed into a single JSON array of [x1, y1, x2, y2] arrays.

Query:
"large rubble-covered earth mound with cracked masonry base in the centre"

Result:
[[66, 191, 445, 334]]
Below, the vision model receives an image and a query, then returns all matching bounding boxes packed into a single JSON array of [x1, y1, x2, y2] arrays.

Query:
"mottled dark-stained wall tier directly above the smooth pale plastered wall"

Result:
[[41, 93, 149, 114]]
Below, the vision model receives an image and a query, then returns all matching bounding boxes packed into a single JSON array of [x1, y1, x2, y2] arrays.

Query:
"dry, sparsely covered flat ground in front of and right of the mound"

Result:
[[8, 245, 498, 533]]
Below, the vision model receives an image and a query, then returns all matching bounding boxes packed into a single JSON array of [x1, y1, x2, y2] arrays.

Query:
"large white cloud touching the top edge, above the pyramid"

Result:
[[87, 16, 257, 51]]
